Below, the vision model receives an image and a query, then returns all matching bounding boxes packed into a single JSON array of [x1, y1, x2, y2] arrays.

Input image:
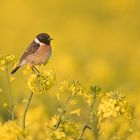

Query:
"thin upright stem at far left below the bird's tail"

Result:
[[5, 68, 15, 120]]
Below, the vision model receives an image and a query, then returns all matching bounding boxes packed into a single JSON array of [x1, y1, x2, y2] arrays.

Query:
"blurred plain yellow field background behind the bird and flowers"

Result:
[[0, 0, 140, 138]]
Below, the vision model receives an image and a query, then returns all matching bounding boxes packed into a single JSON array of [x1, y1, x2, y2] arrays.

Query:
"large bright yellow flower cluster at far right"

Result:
[[97, 92, 128, 122]]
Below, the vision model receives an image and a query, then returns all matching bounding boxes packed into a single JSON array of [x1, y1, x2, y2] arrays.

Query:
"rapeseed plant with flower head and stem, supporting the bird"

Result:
[[22, 69, 56, 129]]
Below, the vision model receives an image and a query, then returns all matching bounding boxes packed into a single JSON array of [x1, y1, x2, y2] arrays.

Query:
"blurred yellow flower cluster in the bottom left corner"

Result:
[[0, 121, 24, 140]]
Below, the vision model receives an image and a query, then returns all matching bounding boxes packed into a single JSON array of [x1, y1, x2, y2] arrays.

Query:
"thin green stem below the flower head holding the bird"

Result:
[[22, 92, 33, 129]]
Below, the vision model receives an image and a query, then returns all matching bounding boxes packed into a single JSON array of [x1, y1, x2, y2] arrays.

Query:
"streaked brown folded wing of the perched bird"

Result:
[[20, 41, 40, 61]]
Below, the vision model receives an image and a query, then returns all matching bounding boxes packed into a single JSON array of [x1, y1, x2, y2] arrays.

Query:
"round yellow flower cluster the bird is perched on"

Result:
[[27, 69, 56, 93]]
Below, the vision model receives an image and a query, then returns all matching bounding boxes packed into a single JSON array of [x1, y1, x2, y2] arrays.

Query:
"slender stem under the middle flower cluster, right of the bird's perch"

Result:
[[55, 93, 72, 129]]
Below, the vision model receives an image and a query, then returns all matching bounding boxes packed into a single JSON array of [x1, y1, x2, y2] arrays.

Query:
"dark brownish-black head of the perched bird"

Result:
[[36, 33, 53, 45]]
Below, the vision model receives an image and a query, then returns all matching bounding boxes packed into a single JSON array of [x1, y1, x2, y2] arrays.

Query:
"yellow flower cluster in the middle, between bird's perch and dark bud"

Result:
[[60, 80, 83, 95]]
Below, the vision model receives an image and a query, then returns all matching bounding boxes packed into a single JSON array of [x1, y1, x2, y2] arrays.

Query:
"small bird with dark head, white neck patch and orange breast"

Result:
[[11, 33, 53, 74]]
